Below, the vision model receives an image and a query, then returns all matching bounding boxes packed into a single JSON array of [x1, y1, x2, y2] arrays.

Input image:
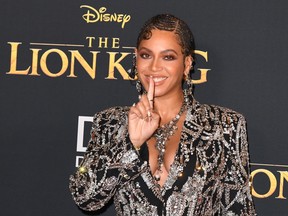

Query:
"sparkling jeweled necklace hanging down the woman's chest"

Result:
[[153, 99, 186, 181]]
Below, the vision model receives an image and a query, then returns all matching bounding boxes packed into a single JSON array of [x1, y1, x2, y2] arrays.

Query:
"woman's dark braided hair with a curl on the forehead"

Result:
[[136, 14, 195, 59]]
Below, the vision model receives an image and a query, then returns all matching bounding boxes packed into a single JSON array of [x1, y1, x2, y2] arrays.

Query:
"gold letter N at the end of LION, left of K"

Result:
[[68, 50, 100, 79]]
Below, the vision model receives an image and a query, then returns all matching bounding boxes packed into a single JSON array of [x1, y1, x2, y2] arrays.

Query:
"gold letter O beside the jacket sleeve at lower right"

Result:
[[251, 169, 277, 198]]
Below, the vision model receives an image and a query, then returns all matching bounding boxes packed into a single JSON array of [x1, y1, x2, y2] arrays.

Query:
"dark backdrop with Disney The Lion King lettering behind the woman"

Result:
[[0, 0, 288, 216]]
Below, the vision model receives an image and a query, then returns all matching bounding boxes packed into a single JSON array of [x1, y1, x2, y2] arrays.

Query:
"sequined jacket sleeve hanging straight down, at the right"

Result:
[[221, 114, 256, 216]]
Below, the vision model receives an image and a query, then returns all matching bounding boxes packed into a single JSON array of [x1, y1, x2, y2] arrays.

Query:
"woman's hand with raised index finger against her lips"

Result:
[[128, 77, 160, 149]]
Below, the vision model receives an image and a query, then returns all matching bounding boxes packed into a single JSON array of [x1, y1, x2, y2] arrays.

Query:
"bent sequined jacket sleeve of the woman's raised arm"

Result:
[[69, 108, 146, 211]]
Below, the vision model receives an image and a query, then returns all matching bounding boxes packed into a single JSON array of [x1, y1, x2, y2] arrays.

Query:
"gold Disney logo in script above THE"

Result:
[[80, 5, 131, 28]]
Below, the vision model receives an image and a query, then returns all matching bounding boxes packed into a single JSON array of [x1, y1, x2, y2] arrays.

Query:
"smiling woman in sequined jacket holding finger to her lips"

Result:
[[70, 14, 255, 216]]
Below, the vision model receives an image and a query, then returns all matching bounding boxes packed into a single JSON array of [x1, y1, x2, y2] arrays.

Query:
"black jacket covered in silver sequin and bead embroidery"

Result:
[[69, 93, 256, 216]]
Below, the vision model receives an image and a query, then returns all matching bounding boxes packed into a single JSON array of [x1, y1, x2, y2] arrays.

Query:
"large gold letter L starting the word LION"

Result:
[[6, 42, 31, 75]]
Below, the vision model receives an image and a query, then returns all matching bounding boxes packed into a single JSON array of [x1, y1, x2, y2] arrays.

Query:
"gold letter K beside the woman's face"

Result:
[[105, 52, 131, 80]]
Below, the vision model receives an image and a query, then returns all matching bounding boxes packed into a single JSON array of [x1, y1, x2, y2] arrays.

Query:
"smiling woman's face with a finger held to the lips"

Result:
[[136, 30, 192, 97]]
